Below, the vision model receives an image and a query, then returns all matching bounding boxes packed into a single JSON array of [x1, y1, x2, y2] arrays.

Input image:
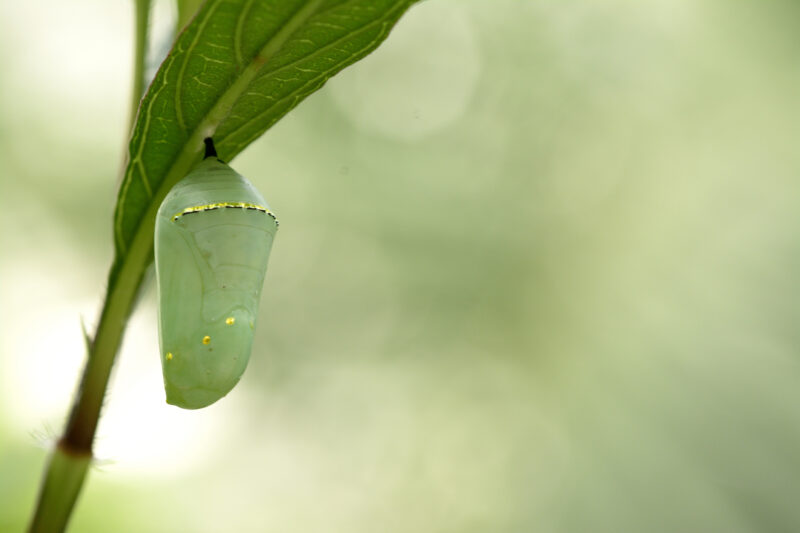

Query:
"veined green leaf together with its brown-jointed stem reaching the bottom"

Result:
[[31, 0, 424, 531]]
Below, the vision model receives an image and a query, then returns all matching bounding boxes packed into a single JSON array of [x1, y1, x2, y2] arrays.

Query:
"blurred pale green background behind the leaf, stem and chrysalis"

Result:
[[0, 0, 800, 533]]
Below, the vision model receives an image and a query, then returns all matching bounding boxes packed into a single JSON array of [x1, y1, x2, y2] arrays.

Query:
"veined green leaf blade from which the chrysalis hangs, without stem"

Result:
[[109, 0, 414, 288]]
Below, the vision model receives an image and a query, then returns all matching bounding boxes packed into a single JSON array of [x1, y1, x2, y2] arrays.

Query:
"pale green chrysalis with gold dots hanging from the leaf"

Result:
[[155, 138, 278, 409]]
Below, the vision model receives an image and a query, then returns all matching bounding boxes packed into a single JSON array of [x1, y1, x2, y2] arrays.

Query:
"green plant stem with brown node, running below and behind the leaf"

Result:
[[29, 0, 152, 533]]
